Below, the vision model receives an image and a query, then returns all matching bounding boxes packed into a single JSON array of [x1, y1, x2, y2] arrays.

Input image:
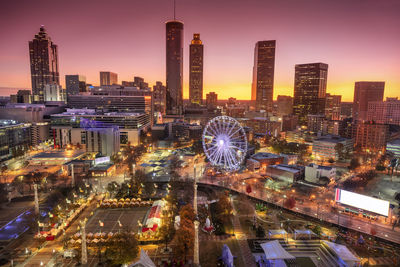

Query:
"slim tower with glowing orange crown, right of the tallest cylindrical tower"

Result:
[[189, 33, 204, 105]]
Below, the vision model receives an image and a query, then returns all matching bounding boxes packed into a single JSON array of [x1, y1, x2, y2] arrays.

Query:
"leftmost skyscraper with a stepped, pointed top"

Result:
[[29, 25, 60, 102]]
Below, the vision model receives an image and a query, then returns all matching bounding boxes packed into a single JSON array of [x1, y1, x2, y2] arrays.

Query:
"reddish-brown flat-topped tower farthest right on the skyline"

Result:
[[353, 82, 385, 121]]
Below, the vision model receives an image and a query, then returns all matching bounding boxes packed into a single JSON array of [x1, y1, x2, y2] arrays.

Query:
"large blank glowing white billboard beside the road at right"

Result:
[[335, 188, 390, 217]]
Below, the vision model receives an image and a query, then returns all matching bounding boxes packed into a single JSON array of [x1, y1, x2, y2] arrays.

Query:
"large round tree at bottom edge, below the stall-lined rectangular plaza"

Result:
[[105, 230, 139, 265]]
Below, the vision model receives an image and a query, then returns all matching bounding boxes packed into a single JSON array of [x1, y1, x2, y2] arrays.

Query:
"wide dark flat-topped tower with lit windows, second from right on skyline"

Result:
[[293, 63, 328, 125]]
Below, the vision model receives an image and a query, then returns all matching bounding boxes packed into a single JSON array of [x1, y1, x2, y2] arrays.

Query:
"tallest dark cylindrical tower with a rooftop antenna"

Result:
[[165, 20, 183, 115]]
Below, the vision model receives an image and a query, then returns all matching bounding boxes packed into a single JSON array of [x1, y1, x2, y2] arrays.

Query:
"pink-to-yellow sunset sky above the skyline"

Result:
[[0, 0, 400, 101]]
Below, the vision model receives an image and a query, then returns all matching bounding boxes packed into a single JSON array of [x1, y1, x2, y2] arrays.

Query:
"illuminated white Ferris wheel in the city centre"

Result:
[[203, 116, 247, 171]]
